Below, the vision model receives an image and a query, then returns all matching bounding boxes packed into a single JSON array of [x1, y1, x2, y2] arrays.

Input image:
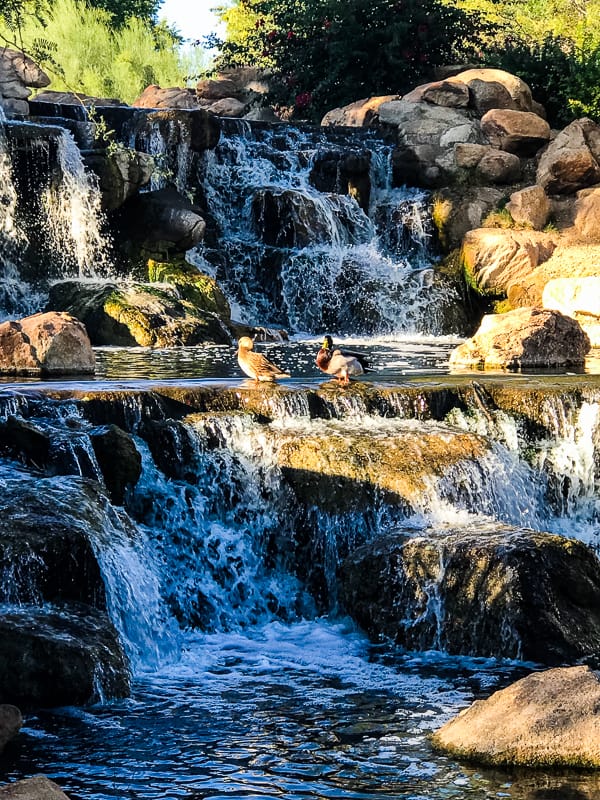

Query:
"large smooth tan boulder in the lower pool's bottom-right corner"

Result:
[[432, 666, 600, 768]]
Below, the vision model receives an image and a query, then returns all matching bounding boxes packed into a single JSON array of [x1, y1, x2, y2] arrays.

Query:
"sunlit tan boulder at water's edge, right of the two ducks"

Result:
[[449, 308, 590, 369]]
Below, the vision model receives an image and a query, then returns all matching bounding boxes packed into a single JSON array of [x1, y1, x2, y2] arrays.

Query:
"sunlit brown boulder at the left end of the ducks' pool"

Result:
[[0, 311, 96, 375]]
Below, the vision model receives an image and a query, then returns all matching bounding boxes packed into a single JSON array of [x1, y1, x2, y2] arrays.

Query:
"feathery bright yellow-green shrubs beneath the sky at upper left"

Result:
[[0, 0, 205, 103]]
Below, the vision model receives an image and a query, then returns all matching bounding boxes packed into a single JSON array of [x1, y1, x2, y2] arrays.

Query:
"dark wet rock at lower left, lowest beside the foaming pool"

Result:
[[0, 604, 130, 708]]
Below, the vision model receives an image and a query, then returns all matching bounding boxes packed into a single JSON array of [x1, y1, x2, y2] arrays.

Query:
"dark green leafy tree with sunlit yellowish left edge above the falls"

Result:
[[213, 0, 490, 118]]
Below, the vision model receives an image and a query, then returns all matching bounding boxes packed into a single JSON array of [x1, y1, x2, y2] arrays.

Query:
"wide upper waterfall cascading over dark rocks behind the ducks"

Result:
[[186, 121, 451, 334]]
